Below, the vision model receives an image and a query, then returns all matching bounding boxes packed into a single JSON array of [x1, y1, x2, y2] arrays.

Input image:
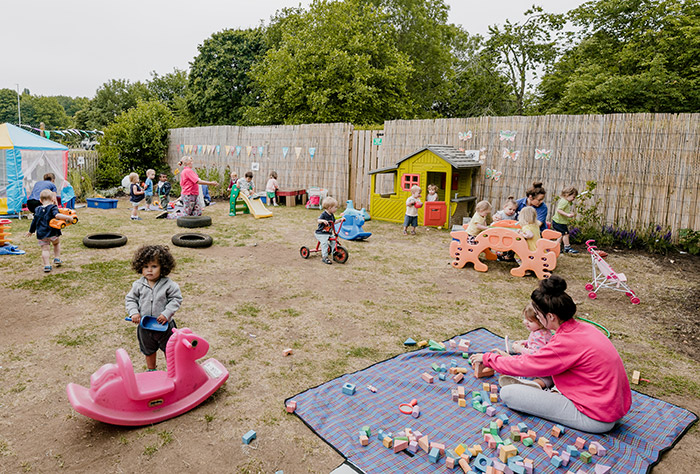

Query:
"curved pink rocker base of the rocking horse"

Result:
[[66, 359, 228, 426]]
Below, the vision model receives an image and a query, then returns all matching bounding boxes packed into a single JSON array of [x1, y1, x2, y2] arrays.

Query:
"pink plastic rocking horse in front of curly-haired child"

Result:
[[66, 328, 228, 426]]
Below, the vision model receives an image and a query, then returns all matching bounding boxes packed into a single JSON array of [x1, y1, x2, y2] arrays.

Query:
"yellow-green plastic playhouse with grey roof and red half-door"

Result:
[[369, 145, 481, 227]]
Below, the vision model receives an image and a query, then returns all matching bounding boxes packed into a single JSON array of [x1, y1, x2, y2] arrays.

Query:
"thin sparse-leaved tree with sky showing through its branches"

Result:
[[486, 6, 564, 114]]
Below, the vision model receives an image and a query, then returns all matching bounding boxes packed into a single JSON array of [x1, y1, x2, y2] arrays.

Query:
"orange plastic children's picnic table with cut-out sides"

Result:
[[450, 221, 561, 280]]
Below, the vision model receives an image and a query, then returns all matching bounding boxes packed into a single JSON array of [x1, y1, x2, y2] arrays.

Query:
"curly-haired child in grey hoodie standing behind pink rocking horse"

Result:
[[126, 245, 182, 371]]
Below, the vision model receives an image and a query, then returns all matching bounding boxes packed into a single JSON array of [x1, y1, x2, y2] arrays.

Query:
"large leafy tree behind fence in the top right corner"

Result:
[[539, 0, 700, 114]]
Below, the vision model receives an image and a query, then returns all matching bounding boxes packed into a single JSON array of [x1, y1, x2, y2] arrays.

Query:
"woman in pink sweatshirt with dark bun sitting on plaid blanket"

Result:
[[470, 275, 632, 433]]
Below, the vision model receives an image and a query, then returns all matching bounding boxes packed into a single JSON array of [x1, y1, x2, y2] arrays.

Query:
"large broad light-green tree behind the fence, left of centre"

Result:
[[245, 0, 415, 124]]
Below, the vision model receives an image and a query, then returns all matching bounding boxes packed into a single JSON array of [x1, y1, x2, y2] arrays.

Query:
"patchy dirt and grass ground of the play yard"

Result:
[[0, 200, 700, 473]]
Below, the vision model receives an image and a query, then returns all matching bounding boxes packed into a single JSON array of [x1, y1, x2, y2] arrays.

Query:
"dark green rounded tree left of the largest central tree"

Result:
[[187, 28, 266, 125]]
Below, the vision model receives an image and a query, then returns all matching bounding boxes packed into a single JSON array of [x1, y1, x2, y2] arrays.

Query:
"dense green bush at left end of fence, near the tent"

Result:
[[96, 101, 173, 188]]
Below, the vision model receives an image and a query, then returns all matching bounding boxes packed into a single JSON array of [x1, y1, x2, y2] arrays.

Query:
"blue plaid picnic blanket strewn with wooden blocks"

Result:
[[285, 328, 697, 473]]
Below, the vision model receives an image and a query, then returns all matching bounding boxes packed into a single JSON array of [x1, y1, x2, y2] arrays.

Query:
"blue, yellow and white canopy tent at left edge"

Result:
[[0, 123, 68, 215]]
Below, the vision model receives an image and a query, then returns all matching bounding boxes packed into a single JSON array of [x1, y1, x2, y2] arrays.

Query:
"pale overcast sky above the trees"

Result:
[[0, 0, 584, 97]]
